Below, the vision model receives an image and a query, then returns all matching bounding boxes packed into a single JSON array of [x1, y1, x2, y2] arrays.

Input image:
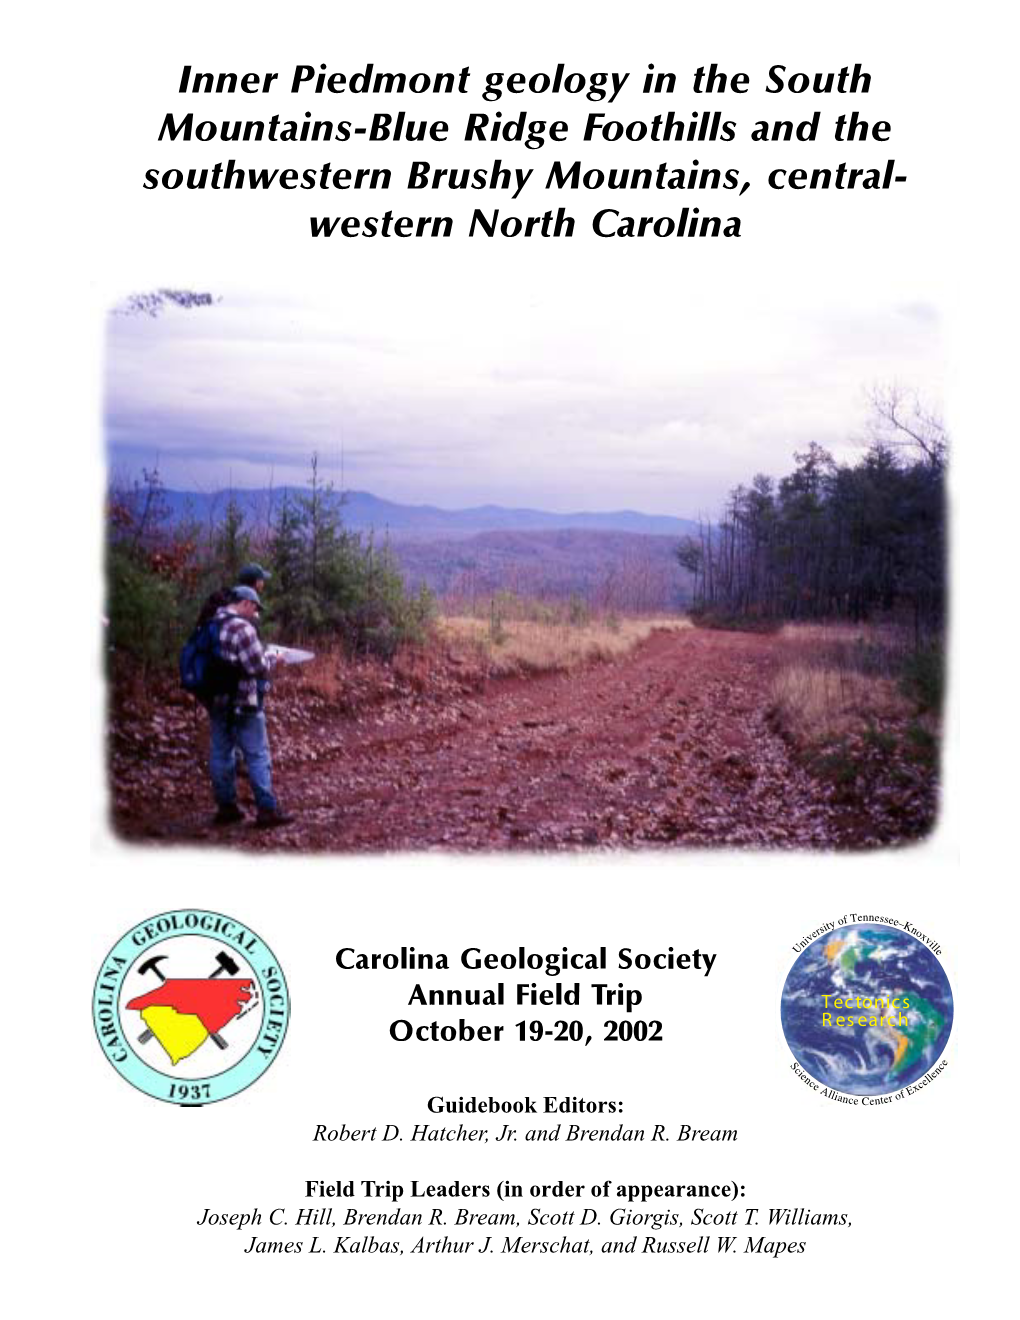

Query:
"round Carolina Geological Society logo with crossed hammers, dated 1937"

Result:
[[92, 908, 290, 1106]]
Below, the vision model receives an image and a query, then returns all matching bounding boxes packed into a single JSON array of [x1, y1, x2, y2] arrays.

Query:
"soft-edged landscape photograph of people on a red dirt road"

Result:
[[102, 288, 950, 853]]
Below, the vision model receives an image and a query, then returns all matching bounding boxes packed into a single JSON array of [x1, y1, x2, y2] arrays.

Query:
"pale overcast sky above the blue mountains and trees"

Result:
[[106, 290, 942, 516]]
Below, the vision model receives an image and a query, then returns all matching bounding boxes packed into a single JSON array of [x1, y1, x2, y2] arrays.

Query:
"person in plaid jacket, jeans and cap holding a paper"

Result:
[[208, 583, 294, 828]]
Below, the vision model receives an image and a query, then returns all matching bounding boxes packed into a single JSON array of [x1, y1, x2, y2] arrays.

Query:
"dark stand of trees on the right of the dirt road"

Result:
[[677, 388, 947, 644]]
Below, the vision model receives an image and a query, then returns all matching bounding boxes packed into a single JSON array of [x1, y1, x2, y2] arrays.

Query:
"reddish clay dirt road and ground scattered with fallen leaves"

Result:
[[111, 630, 922, 853]]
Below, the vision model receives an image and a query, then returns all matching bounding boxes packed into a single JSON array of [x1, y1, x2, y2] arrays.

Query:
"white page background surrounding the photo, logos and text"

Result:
[[5, 4, 1016, 1317]]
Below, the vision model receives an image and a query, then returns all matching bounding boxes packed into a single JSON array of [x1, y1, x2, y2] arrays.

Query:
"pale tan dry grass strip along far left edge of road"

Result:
[[439, 615, 690, 677]]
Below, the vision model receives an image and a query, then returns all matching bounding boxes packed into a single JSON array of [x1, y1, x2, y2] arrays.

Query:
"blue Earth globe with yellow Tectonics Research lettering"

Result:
[[781, 925, 953, 1096]]
